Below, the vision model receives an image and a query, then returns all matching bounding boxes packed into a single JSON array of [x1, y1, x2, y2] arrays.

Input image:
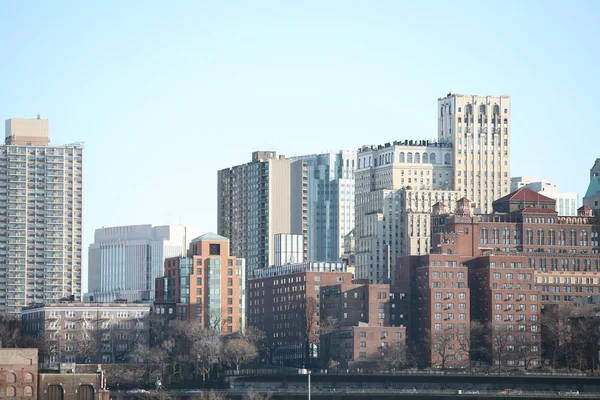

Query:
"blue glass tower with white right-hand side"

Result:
[[291, 150, 357, 261]]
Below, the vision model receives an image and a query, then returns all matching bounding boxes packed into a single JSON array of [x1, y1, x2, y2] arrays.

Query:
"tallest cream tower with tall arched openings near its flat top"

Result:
[[438, 93, 511, 214]]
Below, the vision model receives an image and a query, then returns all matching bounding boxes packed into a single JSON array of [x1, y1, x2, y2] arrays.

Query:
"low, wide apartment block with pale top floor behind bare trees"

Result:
[[21, 303, 150, 366]]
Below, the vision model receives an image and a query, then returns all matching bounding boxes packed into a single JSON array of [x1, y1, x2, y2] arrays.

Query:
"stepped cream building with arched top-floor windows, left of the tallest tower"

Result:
[[354, 140, 459, 283]]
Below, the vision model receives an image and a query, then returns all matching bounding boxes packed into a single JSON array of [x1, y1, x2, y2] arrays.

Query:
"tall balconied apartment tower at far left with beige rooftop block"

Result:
[[0, 117, 83, 314]]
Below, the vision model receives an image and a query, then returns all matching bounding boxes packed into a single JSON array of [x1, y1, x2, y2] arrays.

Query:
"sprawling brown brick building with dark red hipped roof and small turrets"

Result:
[[431, 188, 600, 304]]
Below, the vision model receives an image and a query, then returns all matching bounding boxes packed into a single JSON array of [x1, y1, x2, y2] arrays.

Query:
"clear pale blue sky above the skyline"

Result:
[[0, 0, 600, 292]]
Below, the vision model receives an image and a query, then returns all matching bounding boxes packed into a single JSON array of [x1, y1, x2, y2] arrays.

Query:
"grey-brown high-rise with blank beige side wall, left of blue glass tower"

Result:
[[218, 151, 308, 271]]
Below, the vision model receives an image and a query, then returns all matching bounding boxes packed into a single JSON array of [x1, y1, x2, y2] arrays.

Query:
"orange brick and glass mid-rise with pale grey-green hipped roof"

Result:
[[155, 233, 246, 335]]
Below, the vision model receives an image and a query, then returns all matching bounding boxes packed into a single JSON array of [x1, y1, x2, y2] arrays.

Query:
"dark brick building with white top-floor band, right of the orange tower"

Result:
[[248, 262, 352, 366]]
